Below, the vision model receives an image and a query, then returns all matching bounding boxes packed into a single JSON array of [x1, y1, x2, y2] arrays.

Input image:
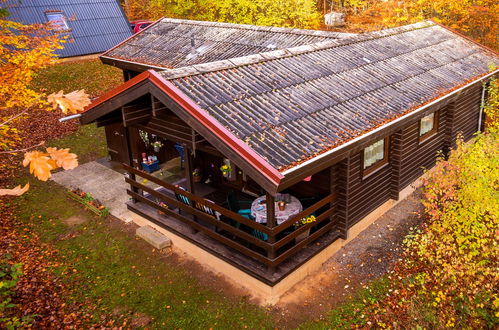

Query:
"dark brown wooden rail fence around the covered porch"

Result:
[[123, 165, 335, 268]]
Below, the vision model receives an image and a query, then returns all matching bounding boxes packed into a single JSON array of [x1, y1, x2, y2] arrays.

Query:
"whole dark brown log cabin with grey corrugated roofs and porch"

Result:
[[81, 20, 498, 300]]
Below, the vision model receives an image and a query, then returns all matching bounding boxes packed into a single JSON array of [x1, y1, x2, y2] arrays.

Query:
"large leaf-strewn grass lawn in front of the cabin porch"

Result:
[[18, 182, 271, 329]]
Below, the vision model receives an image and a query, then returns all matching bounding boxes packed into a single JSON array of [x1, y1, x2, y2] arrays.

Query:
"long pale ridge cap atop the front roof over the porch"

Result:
[[160, 21, 438, 79]]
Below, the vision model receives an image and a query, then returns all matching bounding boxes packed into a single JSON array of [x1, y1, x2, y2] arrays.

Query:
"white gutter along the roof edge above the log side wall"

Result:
[[281, 69, 499, 175]]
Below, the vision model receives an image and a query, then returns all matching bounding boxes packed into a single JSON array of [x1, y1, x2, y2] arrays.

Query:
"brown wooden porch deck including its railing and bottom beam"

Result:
[[124, 165, 340, 285]]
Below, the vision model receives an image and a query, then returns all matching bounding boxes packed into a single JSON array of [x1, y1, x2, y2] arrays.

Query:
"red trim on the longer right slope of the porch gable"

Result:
[[148, 70, 284, 186]]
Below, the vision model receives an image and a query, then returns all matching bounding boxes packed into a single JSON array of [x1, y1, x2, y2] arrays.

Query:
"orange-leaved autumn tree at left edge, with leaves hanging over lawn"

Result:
[[0, 0, 89, 195]]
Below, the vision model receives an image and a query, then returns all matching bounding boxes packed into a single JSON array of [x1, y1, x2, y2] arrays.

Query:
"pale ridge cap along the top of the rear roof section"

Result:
[[160, 17, 357, 38]]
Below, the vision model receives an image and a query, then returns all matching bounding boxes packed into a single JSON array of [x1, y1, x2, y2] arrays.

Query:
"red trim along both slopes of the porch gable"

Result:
[[85, 70, 284, 186]]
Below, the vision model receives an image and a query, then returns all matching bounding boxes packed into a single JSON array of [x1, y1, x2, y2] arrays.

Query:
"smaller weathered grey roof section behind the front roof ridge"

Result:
[[102, 18, 354, 69]]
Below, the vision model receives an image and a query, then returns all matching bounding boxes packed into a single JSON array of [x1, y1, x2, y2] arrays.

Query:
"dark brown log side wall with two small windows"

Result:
[[333, 84, 482, 234]]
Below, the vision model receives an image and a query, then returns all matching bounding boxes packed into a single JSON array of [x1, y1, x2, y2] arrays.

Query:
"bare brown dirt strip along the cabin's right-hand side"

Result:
[[274, 190, 422, 328]]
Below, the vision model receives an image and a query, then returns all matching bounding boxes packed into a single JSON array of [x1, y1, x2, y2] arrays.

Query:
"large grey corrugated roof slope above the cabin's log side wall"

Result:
[[160, 22, 499, 171]]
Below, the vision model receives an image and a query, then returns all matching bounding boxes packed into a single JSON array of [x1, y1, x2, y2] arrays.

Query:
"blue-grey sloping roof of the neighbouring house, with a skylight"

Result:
[[7, 0, 132, 57]]
